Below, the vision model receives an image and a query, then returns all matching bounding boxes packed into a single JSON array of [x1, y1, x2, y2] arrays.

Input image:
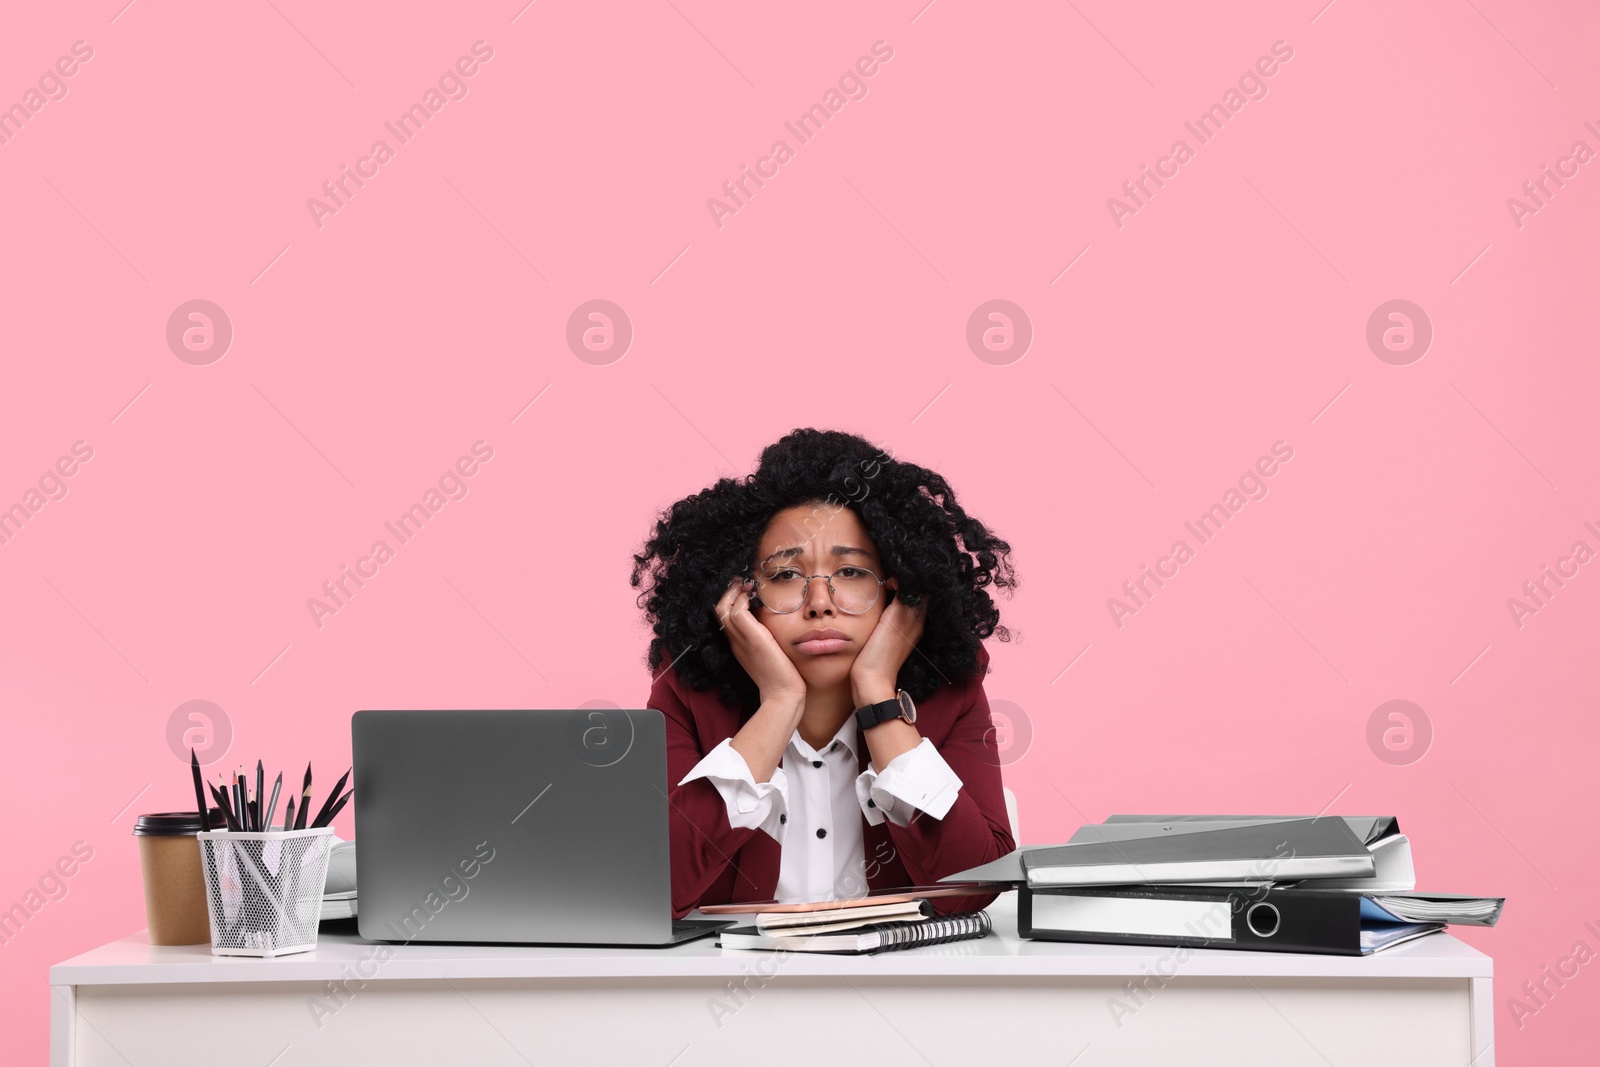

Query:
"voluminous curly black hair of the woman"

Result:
[[629, 429, 1018, 718]]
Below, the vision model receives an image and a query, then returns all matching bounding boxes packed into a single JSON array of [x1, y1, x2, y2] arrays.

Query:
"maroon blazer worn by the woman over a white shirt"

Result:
[[646, 645, 1016, 918]]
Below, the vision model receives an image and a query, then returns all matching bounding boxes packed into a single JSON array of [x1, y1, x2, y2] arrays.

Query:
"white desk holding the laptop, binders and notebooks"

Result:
[[50, 894, 1494, 1067]]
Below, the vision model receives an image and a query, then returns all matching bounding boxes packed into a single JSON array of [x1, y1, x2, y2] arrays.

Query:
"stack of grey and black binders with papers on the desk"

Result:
[[950, 814, 1506, 955]]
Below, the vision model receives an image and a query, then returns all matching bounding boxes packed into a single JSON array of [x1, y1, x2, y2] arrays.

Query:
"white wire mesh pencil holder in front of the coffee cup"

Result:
[[197, 825, 333, 958]]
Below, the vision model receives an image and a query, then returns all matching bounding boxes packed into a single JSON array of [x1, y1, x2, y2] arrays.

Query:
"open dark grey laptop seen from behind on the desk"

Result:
[[350, 709, 733, 945]]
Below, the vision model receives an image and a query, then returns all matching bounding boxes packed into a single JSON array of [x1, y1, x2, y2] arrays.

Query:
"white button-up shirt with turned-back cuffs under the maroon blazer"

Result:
[[678, 715, 962, 902]]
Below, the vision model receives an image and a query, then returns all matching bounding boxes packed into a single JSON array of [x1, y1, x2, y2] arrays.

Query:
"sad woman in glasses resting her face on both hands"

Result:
[[632, 429, 1018, 918]]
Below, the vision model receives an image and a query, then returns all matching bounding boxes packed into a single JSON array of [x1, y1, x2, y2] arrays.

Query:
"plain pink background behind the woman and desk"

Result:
[[0, 0, 1600, 1064]]
